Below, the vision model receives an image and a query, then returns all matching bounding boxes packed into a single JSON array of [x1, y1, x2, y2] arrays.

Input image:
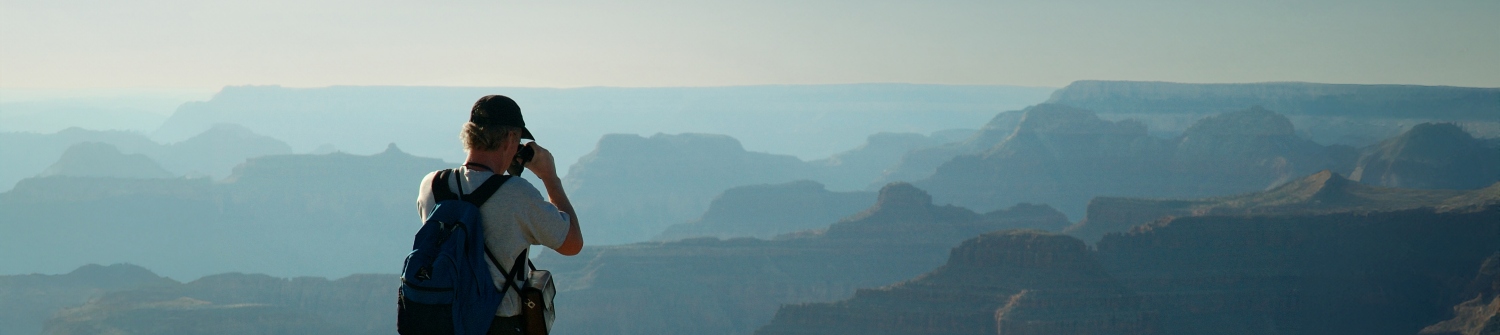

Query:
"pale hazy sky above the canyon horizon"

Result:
[[0, 0, 1500, 89]]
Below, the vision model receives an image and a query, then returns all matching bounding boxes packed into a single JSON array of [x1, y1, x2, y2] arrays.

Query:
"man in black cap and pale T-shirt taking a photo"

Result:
[[417, 95, 584, 333]]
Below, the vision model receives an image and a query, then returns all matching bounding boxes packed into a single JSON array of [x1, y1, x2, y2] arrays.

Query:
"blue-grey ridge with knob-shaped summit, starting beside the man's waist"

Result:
[[536, 183, 1067, 333]]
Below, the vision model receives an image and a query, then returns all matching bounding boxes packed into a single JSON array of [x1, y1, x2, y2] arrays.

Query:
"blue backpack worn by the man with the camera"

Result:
[[396, 170, 525, 335]]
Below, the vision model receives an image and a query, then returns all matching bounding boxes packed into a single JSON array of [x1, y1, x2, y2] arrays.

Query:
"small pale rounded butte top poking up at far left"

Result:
[[39, 141, 174, 179]]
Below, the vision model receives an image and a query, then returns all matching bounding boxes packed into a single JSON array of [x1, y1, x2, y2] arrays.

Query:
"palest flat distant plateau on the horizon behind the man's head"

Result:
[[152, 84, 1055, 174]]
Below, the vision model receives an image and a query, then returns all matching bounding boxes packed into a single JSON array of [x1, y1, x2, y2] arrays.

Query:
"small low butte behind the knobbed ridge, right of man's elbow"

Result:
[[656, 180, 876, 240]]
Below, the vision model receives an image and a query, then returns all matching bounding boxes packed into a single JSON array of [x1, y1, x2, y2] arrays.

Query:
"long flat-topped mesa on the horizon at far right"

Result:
[[1047, 80, 1500, 147]]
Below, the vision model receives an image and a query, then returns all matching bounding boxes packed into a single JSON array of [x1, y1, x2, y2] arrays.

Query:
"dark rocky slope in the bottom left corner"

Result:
[[0, 264, 179, 333]]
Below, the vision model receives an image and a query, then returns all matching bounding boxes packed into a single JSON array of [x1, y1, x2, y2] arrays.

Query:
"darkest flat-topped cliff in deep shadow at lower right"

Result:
[[1098, 207, 1500, 333]]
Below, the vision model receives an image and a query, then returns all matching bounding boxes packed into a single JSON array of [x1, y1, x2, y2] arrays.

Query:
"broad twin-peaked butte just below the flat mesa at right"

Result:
[[917, 105, 1356, 218]]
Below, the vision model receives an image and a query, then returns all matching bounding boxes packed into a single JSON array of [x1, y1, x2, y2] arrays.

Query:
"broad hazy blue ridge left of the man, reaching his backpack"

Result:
[[0, 146, 453, 278]]
